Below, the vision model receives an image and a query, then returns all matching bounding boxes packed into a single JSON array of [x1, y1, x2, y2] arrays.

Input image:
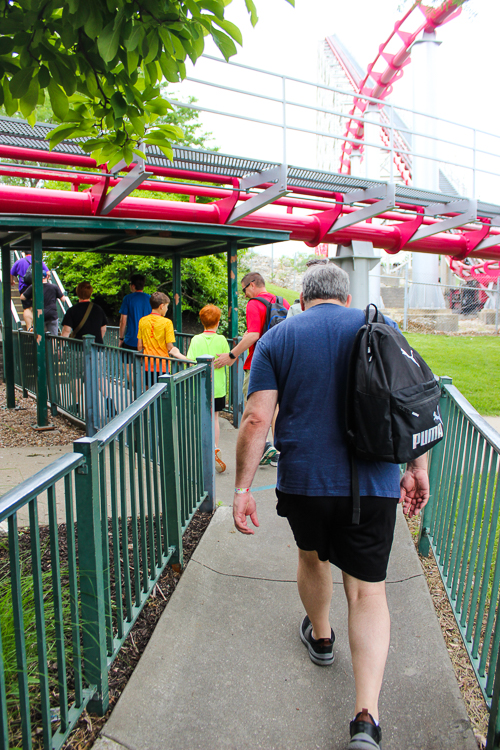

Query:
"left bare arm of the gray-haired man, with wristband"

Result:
[[233, 391, 278, 534]]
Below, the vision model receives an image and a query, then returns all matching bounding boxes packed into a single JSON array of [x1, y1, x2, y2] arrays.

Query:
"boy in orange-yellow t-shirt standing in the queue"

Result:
[[137, 292, 187, 378]]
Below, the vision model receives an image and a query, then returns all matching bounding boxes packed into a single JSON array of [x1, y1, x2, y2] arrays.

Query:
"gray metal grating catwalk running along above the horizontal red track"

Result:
[[0, 117, 500, 218]]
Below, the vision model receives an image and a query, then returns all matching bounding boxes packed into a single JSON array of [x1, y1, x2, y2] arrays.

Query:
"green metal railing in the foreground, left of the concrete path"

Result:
[[0, 358, 214, 750]]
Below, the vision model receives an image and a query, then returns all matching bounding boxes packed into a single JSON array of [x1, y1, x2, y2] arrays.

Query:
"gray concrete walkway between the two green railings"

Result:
[[94, 422, 477, 750]]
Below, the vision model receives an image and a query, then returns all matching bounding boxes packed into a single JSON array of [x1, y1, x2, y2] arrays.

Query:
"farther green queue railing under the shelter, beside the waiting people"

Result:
[[5, 328, 243, 436]]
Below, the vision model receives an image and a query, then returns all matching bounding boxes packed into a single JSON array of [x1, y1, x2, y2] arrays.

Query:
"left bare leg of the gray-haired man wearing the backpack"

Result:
[[297, 549, 333, 639]]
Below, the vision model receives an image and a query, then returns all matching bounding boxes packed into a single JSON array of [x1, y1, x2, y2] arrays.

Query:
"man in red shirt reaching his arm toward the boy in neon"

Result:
[[214, 272, 290, 466]]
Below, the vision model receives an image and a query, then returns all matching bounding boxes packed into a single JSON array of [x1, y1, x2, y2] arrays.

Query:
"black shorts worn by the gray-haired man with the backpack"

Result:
[[276, 490, 398, 583]]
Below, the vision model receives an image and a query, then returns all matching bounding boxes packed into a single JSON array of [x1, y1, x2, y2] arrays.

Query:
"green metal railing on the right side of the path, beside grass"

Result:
[[419, 378, 500, 750]]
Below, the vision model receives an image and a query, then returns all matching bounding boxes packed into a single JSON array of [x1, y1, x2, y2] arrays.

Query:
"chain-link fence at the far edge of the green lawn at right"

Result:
[[379, 269, 500, 334]]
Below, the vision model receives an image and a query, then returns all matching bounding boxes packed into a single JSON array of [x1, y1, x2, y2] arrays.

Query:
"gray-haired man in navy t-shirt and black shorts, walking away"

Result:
[[233, 264, 429, 750]]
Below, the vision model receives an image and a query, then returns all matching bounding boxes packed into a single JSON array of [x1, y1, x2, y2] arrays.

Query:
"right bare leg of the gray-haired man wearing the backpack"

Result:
[[342, 573, 391, 721]]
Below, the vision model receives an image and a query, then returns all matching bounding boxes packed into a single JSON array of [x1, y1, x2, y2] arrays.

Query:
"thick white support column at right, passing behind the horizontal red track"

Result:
[[410, 31, 445, 309]]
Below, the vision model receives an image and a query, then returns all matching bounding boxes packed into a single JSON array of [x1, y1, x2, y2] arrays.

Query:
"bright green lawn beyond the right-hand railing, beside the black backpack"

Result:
[[405, 333, 500, 416]]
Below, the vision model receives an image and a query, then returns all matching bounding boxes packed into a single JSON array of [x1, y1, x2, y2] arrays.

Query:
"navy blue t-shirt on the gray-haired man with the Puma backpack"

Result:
[[248, 302, 399, 497]]
